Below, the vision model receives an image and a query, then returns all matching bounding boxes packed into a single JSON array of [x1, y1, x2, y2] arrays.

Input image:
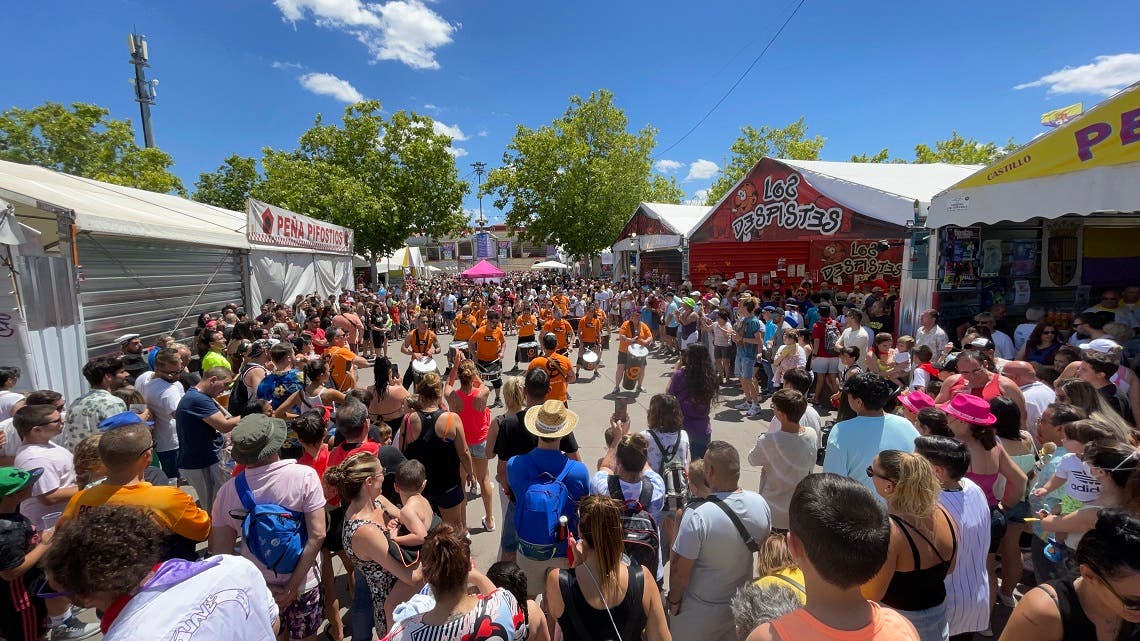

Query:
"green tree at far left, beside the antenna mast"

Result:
[[0, 103, 186, 195]]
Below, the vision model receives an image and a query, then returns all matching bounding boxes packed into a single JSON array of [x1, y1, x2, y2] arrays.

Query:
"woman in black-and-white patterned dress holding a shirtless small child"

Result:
[[325, 452, 413, 638]]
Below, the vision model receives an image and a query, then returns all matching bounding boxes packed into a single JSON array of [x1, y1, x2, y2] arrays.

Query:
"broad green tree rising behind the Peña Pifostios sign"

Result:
[[252, 100, 470, 255]]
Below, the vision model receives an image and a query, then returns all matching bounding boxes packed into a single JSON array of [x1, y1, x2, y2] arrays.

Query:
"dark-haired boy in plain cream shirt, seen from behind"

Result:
[[748, 389, 819, 532]]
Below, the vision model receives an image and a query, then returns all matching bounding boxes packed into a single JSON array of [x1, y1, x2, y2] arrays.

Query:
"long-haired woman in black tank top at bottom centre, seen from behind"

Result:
[[544, 494, 673, 641]]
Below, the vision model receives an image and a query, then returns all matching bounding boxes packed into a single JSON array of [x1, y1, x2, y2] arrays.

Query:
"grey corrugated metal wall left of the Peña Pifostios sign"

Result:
[[78, 234, 246, 357]]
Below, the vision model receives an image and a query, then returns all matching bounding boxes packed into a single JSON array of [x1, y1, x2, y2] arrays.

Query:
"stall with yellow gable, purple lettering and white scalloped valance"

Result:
[[926, 83, 1140, 327]]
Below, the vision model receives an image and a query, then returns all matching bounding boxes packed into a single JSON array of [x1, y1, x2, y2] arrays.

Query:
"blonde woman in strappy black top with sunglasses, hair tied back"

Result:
[[863, 449, 958, 641]]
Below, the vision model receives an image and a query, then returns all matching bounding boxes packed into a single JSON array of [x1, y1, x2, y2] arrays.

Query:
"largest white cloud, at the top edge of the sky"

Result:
[[274, 0, 459, 68]]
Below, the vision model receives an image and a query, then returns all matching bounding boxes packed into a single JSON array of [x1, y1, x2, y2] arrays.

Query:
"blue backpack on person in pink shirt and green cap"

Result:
[[234, 472, 309, 574]]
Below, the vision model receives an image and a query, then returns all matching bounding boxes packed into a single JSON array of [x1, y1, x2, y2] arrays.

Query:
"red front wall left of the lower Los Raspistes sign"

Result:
[[689, 241, 811, 289]]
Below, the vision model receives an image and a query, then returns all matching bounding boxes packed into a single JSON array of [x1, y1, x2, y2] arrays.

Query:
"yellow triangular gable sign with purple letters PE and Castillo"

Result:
[[954, 82, 1140, 189]]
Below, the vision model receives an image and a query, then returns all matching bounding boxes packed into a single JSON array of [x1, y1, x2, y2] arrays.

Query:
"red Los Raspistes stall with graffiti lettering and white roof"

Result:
[[689, 157, 977, 291]]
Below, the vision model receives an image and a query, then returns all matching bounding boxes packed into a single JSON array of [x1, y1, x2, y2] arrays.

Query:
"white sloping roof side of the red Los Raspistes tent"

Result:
[[773, 159, 979, 225]]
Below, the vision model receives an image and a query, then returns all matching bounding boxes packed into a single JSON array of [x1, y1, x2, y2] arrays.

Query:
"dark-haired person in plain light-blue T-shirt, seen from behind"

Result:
[[823, 372, 919, 500]]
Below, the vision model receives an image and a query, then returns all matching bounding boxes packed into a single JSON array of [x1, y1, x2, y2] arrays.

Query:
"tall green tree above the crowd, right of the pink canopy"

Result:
[[483, 89, 674, 257]]
